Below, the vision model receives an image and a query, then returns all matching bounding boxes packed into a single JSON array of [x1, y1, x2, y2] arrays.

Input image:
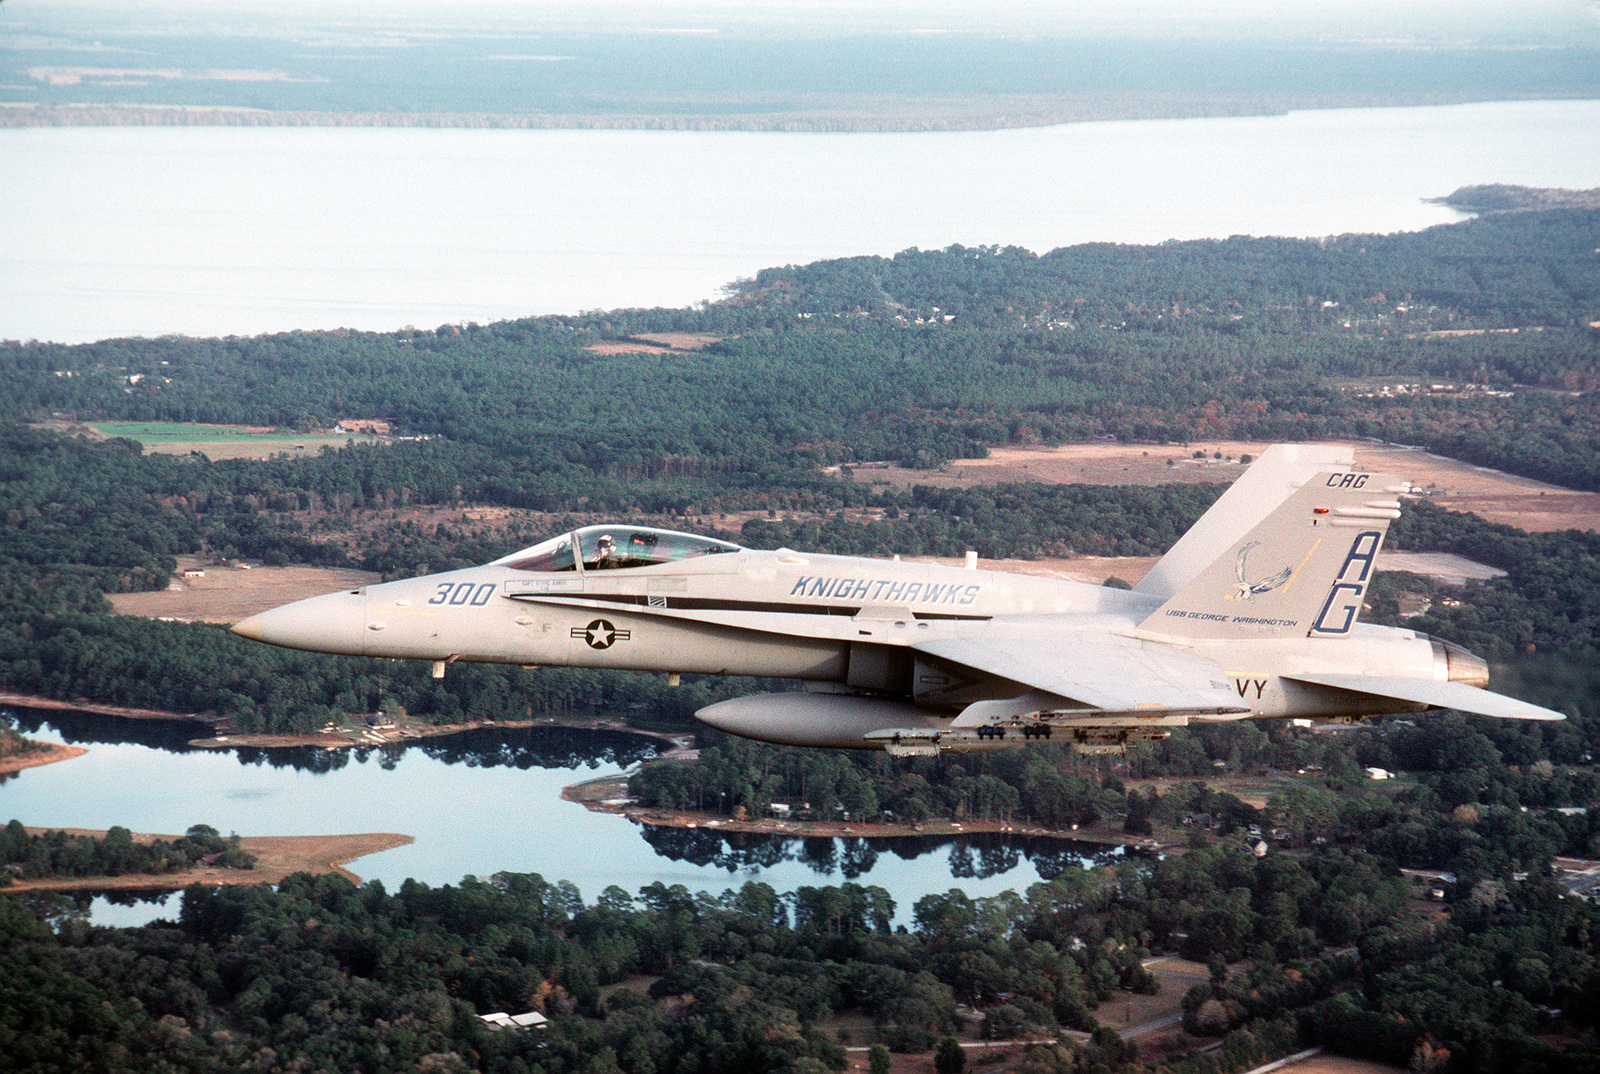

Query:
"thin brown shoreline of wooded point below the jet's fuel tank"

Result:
[[562, 777, 1178, 853]]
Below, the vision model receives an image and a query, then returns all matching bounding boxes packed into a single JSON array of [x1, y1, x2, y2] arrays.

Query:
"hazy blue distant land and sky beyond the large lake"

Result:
[[0, 0, 1600, 130]]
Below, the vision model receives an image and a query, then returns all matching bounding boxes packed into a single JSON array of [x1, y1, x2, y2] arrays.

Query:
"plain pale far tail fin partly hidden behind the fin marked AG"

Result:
[[1134, 443, 1355, 597]]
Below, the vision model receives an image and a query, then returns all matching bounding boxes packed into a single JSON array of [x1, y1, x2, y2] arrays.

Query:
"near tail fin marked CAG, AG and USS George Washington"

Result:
[[1139, 469, 1403, 639]]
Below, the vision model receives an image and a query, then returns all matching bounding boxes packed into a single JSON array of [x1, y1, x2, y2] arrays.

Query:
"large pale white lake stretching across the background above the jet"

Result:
[[0, 101, 1600, 343]]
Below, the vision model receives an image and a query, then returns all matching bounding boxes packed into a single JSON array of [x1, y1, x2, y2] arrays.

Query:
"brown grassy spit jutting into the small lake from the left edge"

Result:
[[6, 828, 414, 892]]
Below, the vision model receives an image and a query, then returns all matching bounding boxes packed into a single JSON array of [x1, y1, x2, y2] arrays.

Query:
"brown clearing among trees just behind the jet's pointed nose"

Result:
[[107, 555, 379, 623]]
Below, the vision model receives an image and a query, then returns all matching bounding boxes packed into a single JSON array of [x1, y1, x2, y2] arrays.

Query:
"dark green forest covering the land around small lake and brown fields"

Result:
[[0, 210, 1600, 1074]]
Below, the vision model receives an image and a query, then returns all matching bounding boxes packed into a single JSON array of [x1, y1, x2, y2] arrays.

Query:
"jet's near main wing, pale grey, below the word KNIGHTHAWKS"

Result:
[[912, 634, 1250, 715]]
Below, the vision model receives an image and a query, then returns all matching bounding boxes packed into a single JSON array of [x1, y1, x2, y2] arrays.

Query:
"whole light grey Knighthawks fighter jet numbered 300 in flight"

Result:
[[234, 445, 1565, 755]]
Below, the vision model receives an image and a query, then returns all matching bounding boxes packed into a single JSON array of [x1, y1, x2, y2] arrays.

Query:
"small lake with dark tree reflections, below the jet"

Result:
[[0, 714, 1117, 924]]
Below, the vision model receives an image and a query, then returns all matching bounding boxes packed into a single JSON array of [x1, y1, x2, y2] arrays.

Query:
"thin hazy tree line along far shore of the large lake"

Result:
[[0, 90, 1600, 133]]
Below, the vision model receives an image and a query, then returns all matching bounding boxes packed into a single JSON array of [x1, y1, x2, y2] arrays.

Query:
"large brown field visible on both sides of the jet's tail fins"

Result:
[[854, 440, 1600, 534]]
